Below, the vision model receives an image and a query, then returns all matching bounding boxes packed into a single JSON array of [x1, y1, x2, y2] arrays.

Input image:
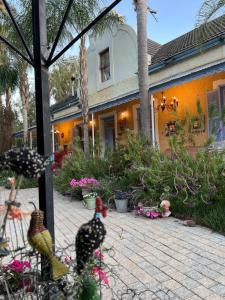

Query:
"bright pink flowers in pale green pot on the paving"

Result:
[[70, 178, 100, 209]]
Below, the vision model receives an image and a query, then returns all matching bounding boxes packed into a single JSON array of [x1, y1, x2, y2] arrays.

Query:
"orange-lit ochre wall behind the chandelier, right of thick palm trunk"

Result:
[[154, 72, 225, 152]]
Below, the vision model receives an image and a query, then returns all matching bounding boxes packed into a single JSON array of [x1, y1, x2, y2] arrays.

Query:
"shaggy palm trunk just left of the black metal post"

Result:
[[19, 63, 30, 146]]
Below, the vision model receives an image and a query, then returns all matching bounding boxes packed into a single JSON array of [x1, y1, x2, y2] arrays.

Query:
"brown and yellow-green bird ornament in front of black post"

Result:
[[27, 202, 68, 280]]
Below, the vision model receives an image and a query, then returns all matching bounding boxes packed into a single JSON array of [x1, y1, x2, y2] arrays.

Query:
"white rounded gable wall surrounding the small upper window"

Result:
[[88, 25, 138, 106]]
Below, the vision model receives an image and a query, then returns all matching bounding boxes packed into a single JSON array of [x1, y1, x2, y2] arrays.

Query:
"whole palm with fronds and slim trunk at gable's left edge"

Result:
[[69, 0, 124, 159]]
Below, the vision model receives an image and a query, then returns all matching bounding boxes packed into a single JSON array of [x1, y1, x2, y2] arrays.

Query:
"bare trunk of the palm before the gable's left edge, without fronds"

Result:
[[80, 35, 89, 159]]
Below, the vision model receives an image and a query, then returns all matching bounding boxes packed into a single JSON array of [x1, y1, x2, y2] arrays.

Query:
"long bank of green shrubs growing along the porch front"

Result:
[[55, 109, 225, 233]]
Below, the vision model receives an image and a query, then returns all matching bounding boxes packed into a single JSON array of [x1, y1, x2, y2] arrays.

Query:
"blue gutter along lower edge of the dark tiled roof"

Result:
[[148, 35, 225, 74]]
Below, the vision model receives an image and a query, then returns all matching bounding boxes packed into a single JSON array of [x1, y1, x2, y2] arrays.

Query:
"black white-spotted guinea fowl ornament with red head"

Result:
[[75, 197, 107, 275]]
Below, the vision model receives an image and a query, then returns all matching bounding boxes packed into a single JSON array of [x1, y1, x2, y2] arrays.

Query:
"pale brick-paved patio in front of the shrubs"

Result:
[[0, 189, 225, 300]]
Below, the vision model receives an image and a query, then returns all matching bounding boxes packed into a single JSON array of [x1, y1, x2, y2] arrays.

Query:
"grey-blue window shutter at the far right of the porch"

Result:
[[207, 89, 225, 142]]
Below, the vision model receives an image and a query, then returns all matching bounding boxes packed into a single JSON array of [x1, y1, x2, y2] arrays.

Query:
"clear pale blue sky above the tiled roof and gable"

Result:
[[116, 0, 203, 44]]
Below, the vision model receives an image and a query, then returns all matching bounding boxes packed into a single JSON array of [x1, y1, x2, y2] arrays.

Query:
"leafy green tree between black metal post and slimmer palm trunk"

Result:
[[50, 57, 79, 102]]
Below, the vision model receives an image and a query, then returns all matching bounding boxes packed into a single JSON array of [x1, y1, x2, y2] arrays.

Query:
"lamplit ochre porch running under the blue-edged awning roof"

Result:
[[51, 72, 225, 152]]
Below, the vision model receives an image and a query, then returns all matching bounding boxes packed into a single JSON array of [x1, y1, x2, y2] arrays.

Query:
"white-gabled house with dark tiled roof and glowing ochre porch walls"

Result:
[[14, 15, 225, 151]]
